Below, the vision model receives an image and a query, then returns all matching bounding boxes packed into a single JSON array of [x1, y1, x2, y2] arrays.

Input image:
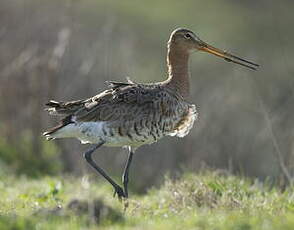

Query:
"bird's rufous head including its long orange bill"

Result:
[[168, 28, 259, 70]]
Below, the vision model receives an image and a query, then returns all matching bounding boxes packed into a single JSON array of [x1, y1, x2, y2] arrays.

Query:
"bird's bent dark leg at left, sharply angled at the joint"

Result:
[[84, 142, 126, 199]]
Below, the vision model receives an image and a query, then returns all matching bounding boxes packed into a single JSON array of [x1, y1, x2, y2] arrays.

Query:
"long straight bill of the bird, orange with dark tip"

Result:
[[198, 42, 259, 70]]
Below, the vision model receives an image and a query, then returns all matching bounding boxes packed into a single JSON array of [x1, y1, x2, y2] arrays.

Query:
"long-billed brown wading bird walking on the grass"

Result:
[[43, 28, 259, 200]]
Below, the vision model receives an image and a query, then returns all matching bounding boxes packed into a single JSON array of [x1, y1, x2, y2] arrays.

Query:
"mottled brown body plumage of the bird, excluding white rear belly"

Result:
[[44, 78, 196, 147]]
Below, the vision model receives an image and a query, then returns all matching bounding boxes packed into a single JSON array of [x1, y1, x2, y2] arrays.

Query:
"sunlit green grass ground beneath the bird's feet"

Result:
[[0, 172, 294, 230]]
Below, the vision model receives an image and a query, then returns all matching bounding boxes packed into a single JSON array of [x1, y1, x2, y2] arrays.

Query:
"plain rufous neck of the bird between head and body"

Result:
[[167, 44, 190, 98]]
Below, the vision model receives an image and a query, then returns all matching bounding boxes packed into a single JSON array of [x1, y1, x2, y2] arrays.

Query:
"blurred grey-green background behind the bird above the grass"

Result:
[[0, 0, 294, 192]]
